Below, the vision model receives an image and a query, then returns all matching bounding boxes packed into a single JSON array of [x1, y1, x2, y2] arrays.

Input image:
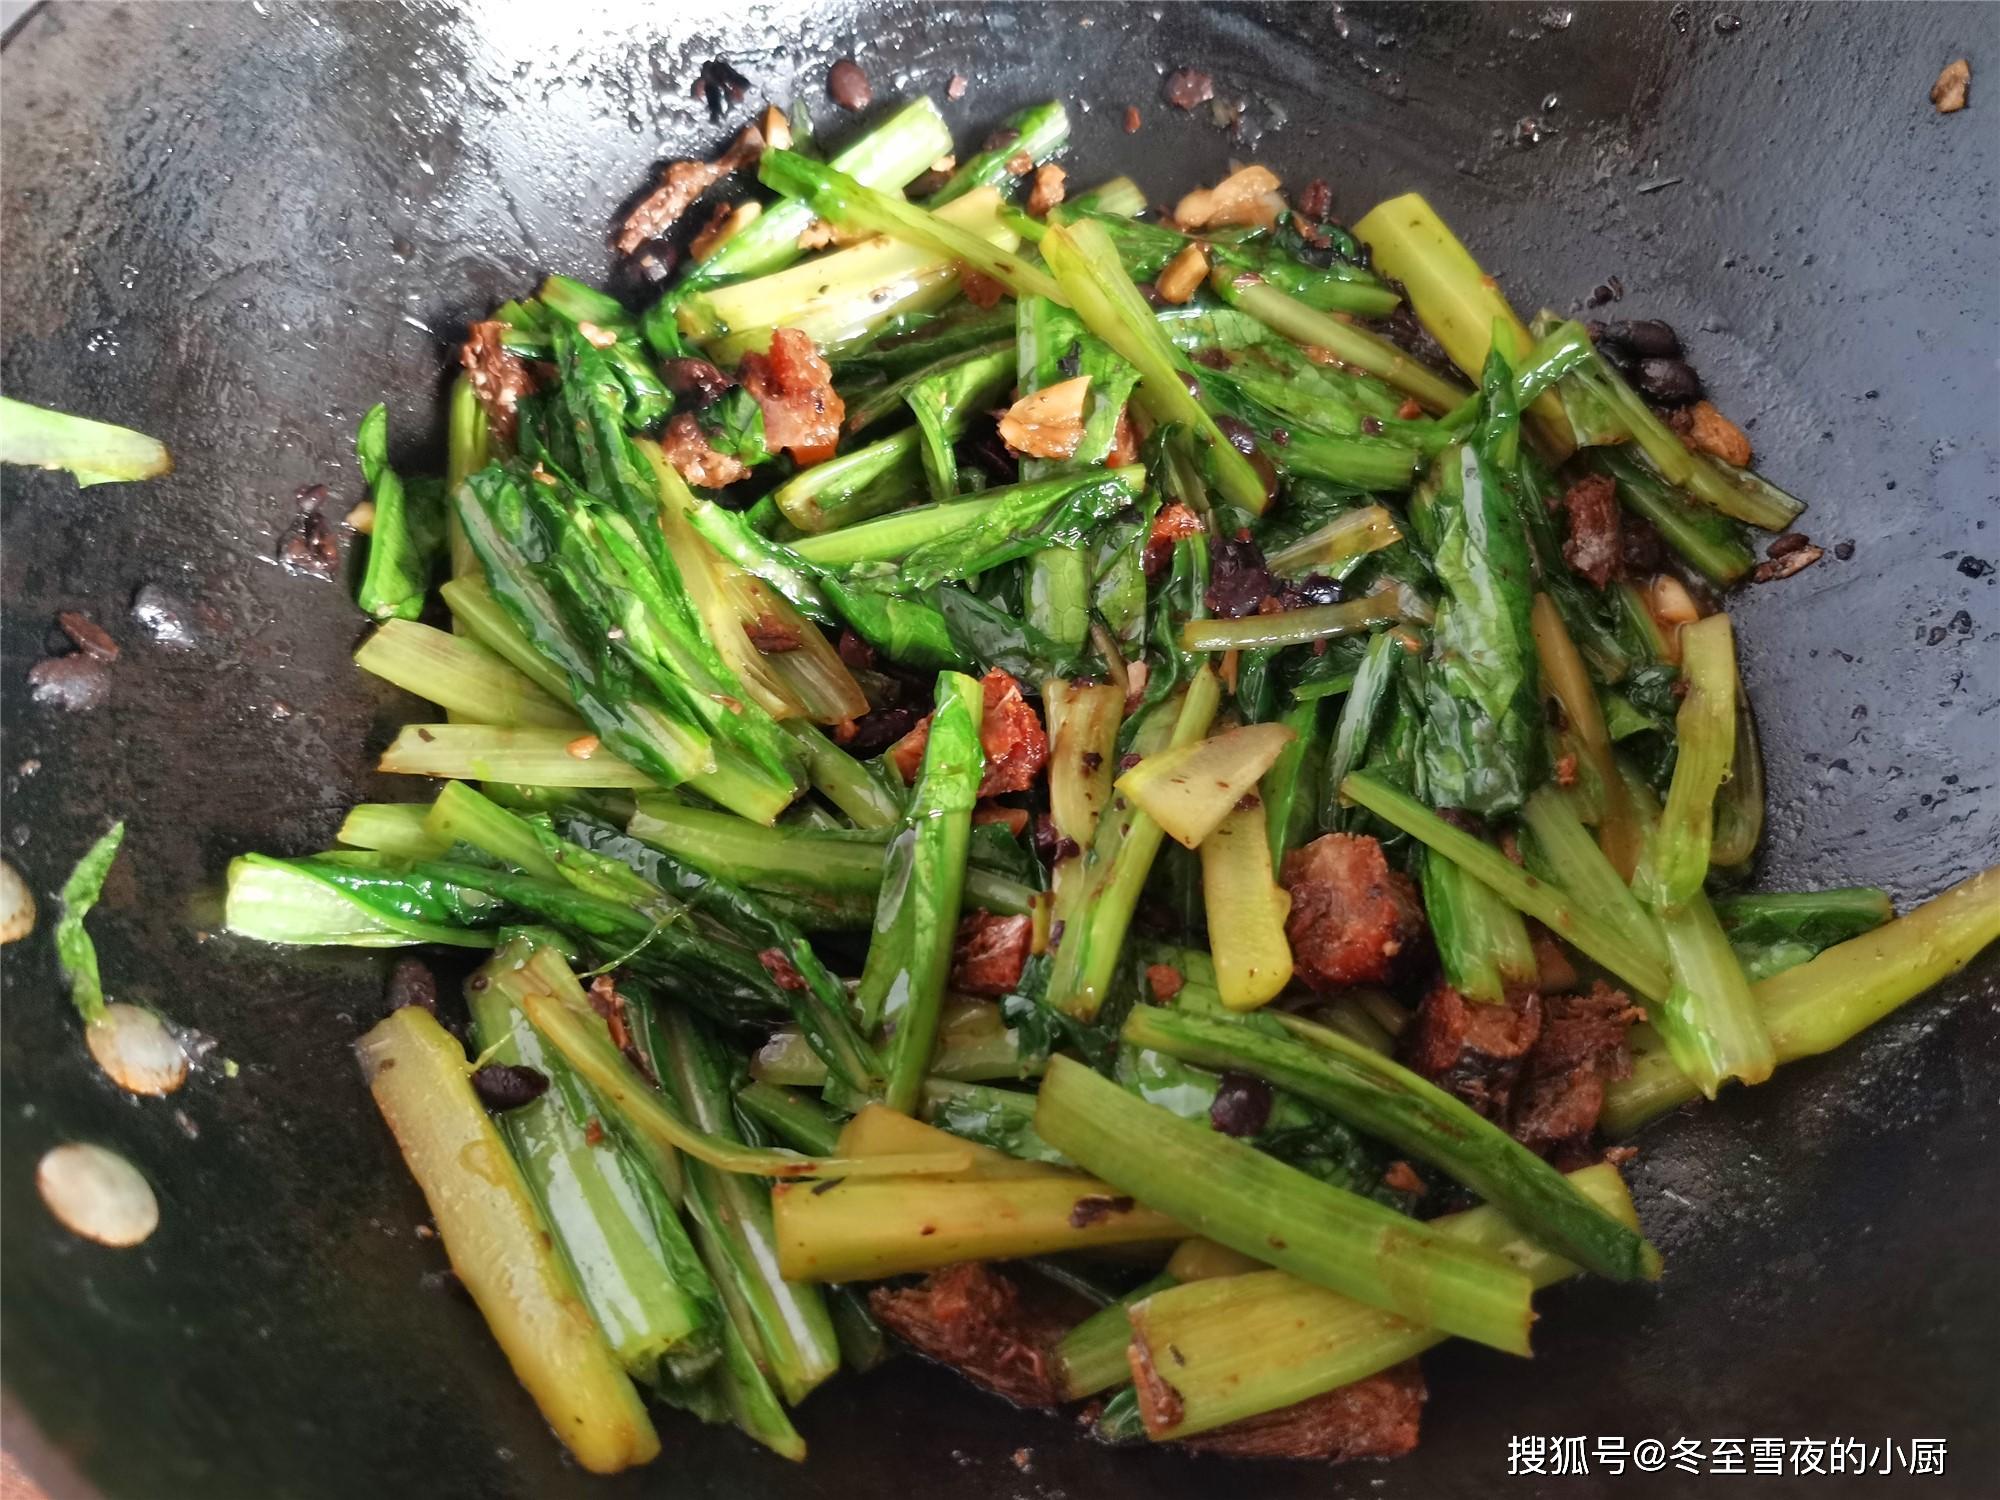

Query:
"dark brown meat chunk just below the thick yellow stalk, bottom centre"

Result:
[[868, 1264, 1068, 1406]]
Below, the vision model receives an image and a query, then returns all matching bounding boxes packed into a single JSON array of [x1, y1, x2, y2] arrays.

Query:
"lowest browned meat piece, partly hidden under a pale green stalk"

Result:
[[1130, 1346, 1428, 1462]]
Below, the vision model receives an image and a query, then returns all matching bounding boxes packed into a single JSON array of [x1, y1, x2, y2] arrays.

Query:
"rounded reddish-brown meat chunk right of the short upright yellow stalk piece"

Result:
[[1284, 834, 1424, 990]]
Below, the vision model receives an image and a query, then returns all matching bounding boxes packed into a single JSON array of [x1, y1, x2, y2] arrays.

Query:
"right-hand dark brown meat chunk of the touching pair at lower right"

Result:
[[1508, 980, 1646, 1170]]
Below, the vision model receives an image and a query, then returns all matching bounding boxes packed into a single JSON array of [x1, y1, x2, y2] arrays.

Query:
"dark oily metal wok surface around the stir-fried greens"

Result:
[[0, 0, 2000, 1500]]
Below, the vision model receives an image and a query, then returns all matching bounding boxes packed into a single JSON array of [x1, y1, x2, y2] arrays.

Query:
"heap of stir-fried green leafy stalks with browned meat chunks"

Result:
[[195, 76, 2000, 1472]]
